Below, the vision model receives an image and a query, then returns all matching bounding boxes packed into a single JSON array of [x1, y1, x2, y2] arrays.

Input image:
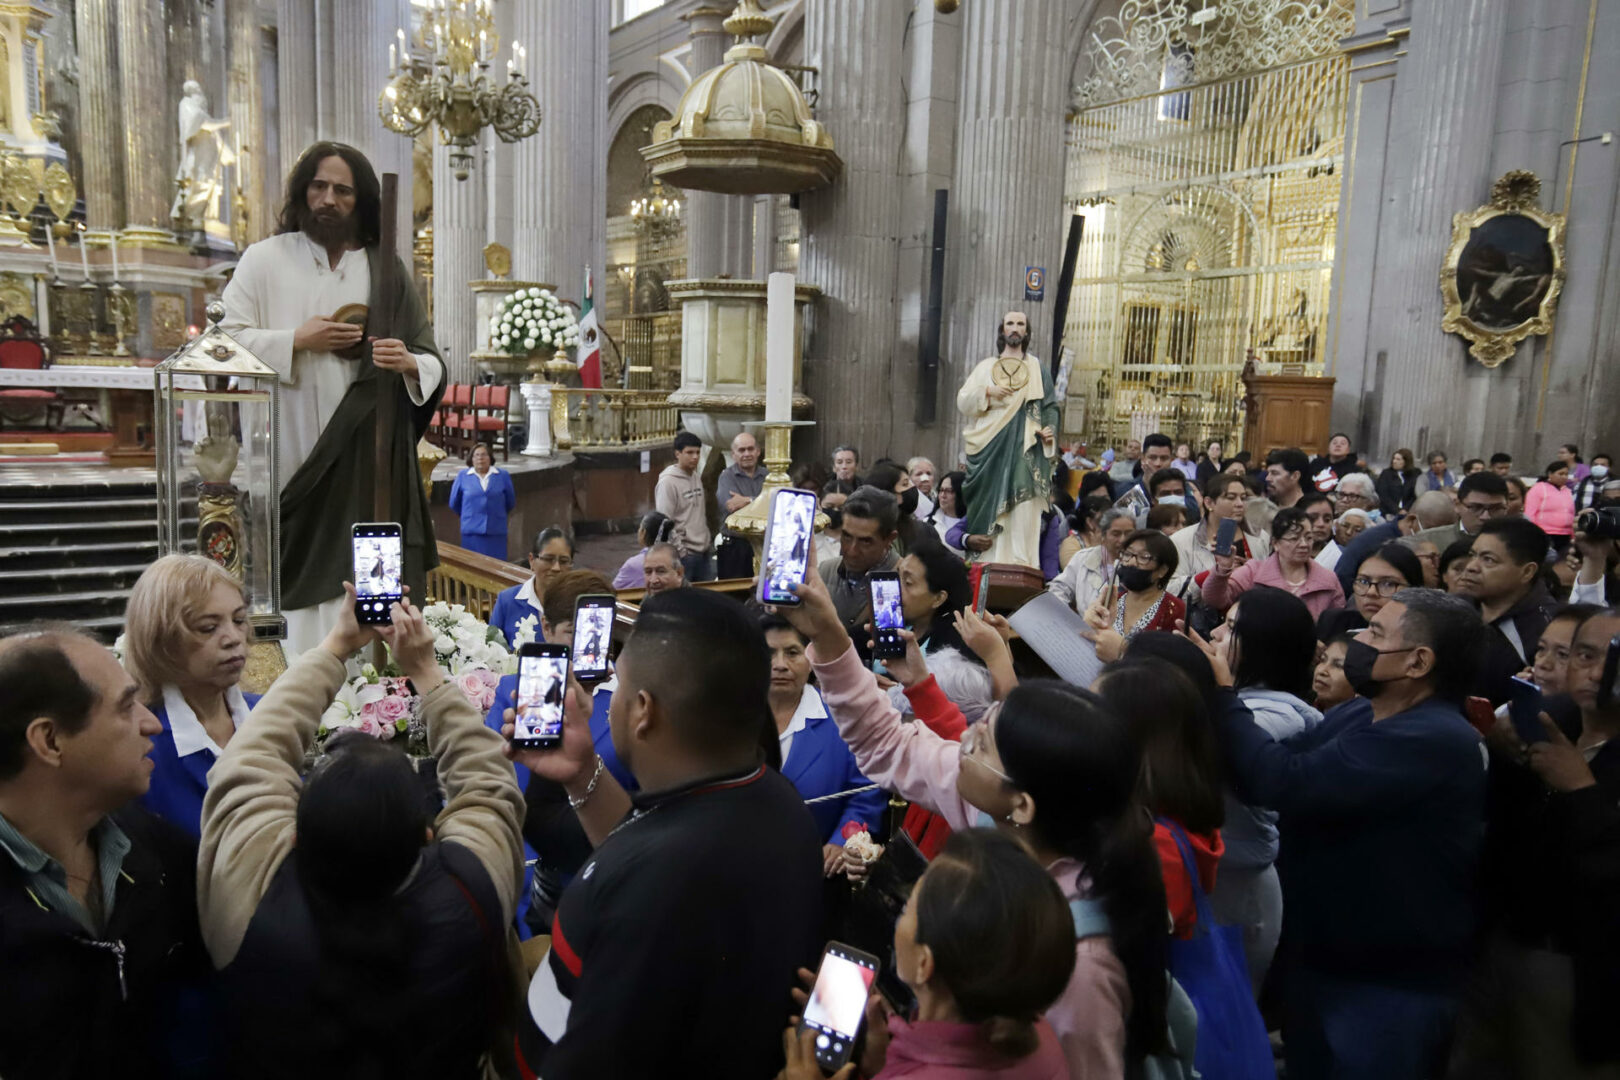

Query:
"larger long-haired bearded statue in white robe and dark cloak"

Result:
[[222, 142, 444, 654]]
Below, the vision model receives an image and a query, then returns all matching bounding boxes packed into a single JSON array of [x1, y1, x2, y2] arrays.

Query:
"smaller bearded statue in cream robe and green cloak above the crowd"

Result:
[[956, 311, 1059, 570]]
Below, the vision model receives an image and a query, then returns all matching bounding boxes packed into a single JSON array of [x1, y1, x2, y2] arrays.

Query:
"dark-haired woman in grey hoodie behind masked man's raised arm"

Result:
[[1210, 588, 1322, 997]]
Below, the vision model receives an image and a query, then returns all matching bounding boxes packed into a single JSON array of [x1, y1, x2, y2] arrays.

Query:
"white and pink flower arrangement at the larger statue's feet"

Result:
[[316, 604, 517, 758]]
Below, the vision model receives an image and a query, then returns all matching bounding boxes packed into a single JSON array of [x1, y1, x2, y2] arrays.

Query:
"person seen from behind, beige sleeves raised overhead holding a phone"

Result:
[[198, 585, 523, 1080]]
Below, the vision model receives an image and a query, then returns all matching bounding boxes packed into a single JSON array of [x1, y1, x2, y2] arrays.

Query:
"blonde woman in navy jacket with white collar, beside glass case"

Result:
[[123, 555, 258, 836]]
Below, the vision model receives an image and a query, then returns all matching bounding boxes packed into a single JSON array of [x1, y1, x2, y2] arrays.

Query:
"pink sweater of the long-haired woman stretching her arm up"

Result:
[[810, 641, 1127, 1080]]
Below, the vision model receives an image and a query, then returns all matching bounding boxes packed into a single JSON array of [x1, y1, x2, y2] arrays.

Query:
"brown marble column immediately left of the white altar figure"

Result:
[[118, 0, 169, 235]]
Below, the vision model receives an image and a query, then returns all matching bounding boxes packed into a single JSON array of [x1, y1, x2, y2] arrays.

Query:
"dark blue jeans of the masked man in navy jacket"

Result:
[[1283, 967, 1458, 1080]]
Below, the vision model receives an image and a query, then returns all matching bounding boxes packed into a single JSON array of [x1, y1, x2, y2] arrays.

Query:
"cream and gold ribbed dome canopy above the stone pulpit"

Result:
[[642, 0, 844, 194]]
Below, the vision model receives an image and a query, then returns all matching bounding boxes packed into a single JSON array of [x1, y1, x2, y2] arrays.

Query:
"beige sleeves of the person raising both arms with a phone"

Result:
[[198, 648, 523, 968]]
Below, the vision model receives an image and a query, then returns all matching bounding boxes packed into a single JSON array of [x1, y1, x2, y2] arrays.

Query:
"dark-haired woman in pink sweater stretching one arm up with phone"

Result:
[[782, 575, 1170, 1077]]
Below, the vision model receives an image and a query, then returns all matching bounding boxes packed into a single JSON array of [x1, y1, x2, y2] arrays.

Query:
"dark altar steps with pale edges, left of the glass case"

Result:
[[0, 468, 196, 643]]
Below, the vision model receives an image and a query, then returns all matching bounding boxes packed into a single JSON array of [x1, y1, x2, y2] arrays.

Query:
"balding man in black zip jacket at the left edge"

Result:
[[0, 630, 211, 1080]]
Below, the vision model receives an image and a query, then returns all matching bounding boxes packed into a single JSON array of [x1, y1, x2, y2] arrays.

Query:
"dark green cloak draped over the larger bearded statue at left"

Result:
[[280, 246, 444, 610]]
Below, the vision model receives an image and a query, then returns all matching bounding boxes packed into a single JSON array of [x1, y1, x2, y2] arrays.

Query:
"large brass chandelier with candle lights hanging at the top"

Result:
[[377, 0, 539, 180]]
